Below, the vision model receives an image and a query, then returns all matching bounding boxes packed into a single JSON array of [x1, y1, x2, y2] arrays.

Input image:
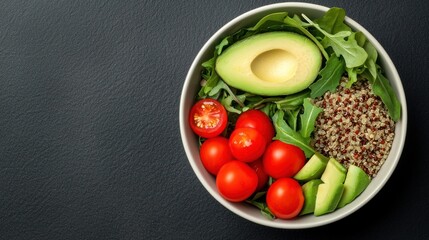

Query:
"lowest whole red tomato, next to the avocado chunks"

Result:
[[266, 178, 304, 219]]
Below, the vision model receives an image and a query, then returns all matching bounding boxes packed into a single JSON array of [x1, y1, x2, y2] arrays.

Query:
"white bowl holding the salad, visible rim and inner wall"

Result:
[[179, 2, 407, 229]]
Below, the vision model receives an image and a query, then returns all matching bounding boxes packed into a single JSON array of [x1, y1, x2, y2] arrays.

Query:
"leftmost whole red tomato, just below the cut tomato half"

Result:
[[200, 136, 233, 175]]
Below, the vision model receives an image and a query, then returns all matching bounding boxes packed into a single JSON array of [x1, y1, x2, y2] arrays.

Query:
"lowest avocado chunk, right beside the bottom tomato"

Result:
[[314, 182, 344, 216]]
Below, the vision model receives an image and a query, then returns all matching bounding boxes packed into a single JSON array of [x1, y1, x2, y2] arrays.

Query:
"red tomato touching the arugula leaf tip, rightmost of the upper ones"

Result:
[[262, 140, 305, 179]]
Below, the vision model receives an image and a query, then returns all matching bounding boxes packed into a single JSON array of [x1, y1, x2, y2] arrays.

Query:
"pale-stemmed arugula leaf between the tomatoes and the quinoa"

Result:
[[272, 110, 315, 158]]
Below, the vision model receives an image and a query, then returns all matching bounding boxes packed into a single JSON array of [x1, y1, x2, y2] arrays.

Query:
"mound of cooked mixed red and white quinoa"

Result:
[[311, 77, 395, 178]]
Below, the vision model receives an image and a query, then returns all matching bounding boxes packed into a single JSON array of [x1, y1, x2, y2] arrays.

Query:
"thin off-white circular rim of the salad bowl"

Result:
[[179, 2, 408, 229]]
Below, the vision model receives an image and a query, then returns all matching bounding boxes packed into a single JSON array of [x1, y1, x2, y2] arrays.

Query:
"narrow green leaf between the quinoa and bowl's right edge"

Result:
[[372, 71, 401, 122]]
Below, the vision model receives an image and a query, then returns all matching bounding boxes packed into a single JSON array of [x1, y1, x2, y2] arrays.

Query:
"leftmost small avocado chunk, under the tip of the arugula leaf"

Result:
[[293, 153, 328, 182]]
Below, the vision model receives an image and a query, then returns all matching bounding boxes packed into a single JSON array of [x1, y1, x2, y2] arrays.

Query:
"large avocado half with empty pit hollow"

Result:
[[216, 32, 322, 96]]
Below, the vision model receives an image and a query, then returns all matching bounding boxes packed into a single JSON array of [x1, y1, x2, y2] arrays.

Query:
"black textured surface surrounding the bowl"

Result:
[[0, 0, 429, 239]]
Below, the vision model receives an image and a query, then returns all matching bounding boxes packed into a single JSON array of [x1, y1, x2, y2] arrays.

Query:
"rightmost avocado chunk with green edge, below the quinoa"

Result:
[[338, 165, 371, 208]]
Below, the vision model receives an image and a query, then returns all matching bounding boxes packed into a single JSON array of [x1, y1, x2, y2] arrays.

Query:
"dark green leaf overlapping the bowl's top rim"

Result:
[[314, 7, 351, 34]]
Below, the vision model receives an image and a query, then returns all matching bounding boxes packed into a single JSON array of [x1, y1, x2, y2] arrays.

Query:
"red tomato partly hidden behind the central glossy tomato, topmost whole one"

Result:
[[235, 109, 275, 144]]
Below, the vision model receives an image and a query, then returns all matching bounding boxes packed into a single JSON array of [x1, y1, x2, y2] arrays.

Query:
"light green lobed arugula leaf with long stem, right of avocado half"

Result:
[[302, 14, 368, 68]]
